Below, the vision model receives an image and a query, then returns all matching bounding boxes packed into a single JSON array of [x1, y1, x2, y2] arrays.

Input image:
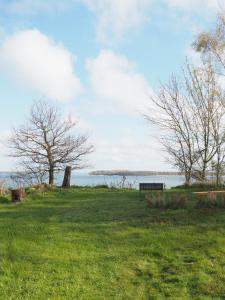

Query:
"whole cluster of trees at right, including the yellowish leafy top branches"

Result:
[[145, 16, 225, 186]]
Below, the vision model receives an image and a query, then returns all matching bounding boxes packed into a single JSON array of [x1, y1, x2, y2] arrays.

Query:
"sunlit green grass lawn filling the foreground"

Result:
[[0, 188, 225, 300]]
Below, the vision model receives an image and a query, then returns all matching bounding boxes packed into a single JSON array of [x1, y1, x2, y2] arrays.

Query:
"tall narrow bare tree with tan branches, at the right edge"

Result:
[[185, 63, 224, 181]]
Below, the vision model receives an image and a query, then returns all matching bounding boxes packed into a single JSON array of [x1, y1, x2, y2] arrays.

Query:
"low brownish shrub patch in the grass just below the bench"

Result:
[[146, 193, 188, 209]]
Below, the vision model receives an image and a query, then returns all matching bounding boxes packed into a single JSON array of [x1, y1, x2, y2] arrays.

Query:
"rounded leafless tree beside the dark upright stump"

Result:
[[9, 101, 93, 184]]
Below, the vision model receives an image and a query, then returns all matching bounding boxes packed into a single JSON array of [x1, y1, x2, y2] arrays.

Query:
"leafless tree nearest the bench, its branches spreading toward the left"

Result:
[[145, 76, 197, 185]]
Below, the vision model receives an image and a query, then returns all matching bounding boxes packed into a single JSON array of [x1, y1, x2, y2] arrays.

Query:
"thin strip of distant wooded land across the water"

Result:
[[89, 170, 184, 176]]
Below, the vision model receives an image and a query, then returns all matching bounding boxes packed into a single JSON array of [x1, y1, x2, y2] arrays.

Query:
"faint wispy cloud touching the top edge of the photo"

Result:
[[81, 0, 153, 42]]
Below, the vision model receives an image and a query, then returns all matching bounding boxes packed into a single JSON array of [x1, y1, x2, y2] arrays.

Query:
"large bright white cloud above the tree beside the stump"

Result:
[[0, 29, 82, 101]]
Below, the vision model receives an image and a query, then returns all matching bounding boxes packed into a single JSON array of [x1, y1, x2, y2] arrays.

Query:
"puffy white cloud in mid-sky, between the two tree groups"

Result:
[[87, 50, 152, 112]]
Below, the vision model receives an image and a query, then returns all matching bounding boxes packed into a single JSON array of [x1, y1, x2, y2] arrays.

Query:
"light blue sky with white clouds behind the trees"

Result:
[[0, 0, 222, 171]]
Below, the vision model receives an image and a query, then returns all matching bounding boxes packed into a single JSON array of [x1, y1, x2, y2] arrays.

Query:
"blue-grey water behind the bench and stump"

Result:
[[0, 172, 184, 189]]
